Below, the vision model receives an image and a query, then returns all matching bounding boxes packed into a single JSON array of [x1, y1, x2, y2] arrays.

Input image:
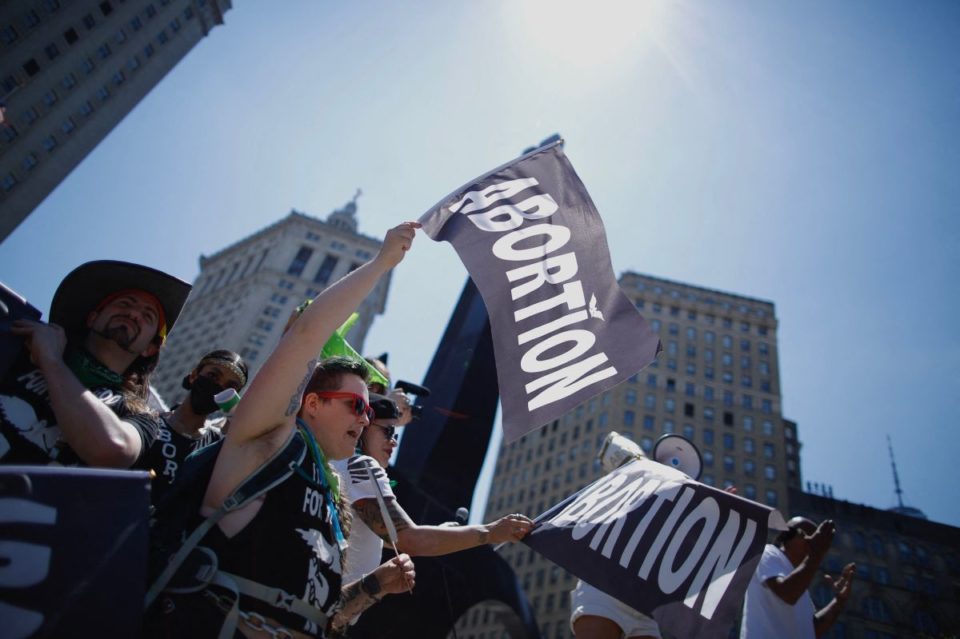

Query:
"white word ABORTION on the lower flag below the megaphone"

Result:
[[549, 464, 758, 619]]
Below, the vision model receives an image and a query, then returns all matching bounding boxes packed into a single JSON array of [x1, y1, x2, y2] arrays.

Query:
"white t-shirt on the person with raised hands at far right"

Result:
[[740, 544, 817, 639]]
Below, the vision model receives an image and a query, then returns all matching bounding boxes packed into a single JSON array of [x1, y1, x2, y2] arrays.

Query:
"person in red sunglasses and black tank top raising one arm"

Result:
[[152, 222, 419, 637]]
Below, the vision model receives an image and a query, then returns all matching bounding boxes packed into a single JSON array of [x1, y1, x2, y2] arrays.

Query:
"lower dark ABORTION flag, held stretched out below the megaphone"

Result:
[[523, 459, 785, 638]]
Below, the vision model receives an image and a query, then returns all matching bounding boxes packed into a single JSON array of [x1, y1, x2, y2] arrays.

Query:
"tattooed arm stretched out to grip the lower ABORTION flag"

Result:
[[353, 497, 533, 557]]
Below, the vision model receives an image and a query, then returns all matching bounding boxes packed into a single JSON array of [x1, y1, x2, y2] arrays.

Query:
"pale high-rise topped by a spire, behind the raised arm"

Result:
[[153, 199, 390, 403]]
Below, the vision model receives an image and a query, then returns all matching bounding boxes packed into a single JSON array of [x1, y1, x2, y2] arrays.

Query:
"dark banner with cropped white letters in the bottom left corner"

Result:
[[0, 466, 150, 639]]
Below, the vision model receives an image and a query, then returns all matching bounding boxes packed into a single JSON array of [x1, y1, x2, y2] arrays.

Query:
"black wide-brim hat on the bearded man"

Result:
[[50, 260, 192, 342]]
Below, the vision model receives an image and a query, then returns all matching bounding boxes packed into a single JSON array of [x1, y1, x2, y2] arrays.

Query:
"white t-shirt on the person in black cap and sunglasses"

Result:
[[332, 455, 395, 584]]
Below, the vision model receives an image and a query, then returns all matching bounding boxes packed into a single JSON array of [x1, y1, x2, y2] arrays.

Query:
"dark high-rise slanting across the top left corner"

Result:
[[0, 0, 231, 241]]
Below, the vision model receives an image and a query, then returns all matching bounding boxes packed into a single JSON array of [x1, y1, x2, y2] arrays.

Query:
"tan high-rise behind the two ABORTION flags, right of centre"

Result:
[[457, 273, 801, 639]]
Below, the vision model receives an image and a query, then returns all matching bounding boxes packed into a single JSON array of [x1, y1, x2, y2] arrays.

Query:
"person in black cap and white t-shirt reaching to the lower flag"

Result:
[[334, 393, 533, 623]]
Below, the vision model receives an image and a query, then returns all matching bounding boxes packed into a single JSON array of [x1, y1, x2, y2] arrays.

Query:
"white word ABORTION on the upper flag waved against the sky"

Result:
[[449, 177, 617, 411]]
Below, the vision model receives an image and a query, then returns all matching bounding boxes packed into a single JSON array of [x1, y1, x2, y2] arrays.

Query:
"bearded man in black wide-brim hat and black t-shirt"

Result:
[[0, 261, 190, 468]]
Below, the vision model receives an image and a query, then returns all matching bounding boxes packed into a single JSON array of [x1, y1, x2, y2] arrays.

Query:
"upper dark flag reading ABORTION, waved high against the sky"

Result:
[[420, 142, 660, 442]]
